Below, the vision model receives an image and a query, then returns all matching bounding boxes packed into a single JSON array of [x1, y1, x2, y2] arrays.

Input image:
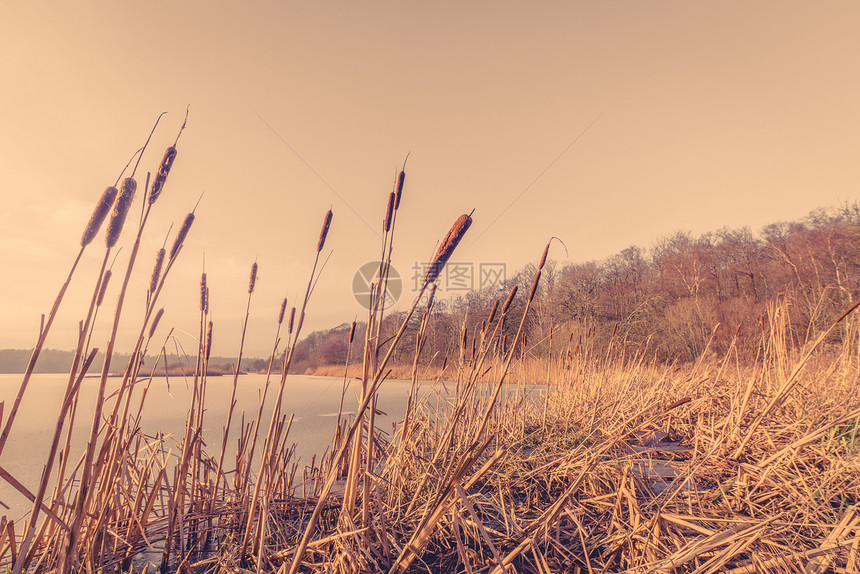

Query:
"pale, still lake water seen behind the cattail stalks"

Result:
[[0, 374, 435, 520]]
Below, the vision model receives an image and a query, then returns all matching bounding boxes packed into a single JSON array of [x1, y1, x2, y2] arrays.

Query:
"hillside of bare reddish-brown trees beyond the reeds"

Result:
[[293, 203, 860, 372]]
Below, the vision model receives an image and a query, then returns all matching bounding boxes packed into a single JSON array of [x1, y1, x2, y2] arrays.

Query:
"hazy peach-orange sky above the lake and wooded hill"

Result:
[[0, 0, 860, 356]]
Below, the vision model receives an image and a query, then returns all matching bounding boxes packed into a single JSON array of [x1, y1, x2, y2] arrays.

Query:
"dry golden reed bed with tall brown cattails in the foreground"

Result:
[[0, 124, 860, 574]]
